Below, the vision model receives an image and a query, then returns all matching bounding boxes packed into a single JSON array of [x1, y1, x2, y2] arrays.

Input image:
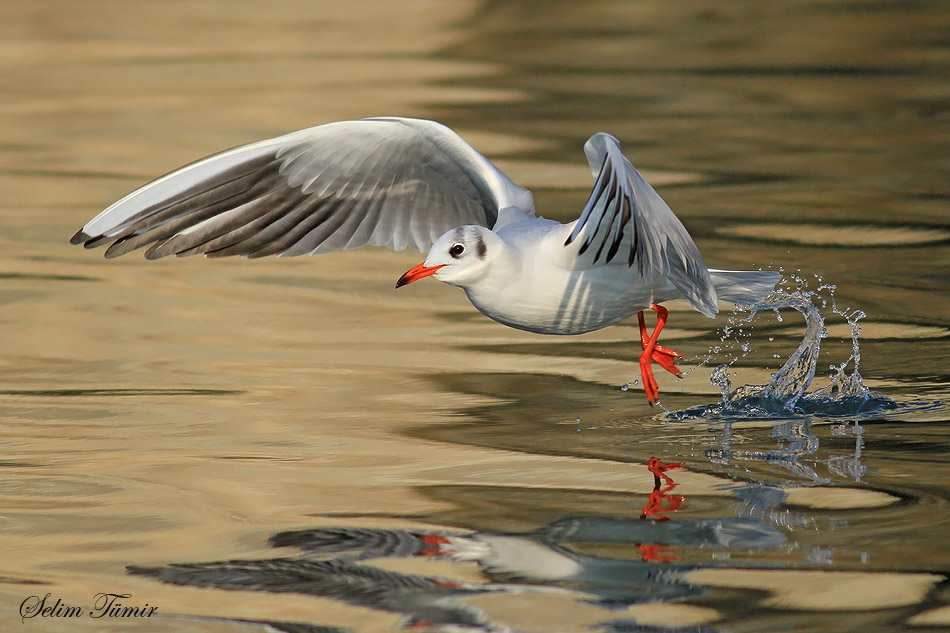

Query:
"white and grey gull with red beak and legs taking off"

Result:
[[71, 117, 781, 405]]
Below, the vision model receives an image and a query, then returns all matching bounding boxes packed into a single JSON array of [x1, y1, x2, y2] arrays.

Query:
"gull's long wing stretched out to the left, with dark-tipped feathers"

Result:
[[71, 117, 534, 259]]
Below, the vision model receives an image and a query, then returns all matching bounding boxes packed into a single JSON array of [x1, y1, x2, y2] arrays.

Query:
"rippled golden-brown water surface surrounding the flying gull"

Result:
[[0, 0, 950, 632]]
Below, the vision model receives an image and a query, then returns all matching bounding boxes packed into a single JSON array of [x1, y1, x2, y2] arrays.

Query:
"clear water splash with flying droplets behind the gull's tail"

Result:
[[668, 275, 897, 420]]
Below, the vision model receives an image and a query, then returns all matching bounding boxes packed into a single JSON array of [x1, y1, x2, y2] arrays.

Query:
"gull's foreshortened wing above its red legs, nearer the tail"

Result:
[[561, 133, 718, 317]]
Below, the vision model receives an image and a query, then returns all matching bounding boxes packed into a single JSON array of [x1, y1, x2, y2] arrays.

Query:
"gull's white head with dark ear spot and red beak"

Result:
[[396, 225, 503, 288]]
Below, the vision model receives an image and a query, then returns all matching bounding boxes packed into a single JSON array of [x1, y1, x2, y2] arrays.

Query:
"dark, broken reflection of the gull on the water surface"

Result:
[[128, 460, 786, 633]]
